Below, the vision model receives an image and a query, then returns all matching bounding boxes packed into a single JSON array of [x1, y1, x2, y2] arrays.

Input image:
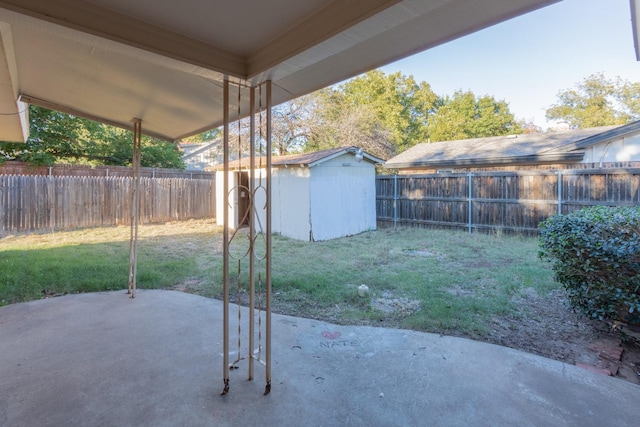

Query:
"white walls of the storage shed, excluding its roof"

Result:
[[222, 153, 376, 241]]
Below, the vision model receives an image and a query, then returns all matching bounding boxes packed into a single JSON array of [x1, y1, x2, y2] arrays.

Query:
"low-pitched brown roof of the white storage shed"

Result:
[[207, 147, 384, 170]]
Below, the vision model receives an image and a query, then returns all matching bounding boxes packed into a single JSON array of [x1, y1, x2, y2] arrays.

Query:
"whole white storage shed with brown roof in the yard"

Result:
[[216, 147, 383, 241]]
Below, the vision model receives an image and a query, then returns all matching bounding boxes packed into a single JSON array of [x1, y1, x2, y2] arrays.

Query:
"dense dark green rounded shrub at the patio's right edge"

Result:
[[539, 206, 640, 324]]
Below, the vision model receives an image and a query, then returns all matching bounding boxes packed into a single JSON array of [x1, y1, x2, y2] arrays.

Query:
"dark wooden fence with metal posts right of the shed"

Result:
[[376, 169, 640, 234]]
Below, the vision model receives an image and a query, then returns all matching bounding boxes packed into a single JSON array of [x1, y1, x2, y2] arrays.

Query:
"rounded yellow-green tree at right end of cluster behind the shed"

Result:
[[428, 91, 523, 141]]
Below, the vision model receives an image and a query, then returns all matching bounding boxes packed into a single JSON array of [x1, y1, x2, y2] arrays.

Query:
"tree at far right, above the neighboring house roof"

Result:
[[546, 73, 640, 129]]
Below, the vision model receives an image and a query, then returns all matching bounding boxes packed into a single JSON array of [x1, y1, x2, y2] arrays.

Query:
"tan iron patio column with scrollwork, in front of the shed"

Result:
[[222, 80, 271, 395]]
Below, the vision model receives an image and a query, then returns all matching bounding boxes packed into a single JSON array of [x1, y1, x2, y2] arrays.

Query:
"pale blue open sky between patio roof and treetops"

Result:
[[382, 0, 640, 130]]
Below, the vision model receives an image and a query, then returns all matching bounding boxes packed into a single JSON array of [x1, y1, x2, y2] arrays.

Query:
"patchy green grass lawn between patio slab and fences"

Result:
[[0, 221, 560, 337]]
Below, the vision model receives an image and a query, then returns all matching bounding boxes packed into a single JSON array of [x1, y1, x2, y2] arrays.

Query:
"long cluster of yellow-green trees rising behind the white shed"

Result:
[[162, 70, 536, 159]]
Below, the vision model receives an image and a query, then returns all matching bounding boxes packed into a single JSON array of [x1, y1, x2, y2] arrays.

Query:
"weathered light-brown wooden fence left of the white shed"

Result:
[[0, 175, 215, 232]]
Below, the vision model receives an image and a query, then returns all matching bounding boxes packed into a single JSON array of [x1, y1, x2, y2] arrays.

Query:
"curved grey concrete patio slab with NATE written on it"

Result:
[[0, 290, 640, 427]]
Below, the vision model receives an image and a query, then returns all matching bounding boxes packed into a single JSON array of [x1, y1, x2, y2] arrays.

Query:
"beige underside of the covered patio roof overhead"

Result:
[[0, 0, 558, 141]]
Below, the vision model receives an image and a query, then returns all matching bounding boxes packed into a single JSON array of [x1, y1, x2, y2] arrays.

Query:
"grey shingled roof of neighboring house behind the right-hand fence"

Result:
[[384, 122, 640, 169]]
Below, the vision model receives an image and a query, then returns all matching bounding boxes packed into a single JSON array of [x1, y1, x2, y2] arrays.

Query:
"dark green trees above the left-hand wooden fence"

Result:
[[0, 106, 184, 168]]
